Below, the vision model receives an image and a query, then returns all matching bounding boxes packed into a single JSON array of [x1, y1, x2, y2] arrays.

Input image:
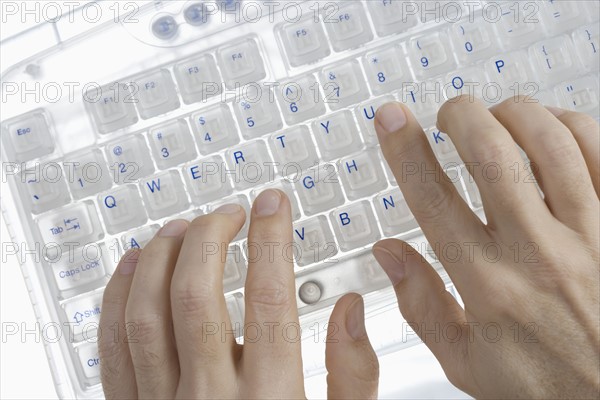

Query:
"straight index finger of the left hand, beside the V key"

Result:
[[243, 190, 303, 393]]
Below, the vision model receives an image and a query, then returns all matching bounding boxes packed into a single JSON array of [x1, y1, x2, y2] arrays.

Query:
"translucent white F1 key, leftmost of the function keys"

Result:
[[83, 82, 138, 133]]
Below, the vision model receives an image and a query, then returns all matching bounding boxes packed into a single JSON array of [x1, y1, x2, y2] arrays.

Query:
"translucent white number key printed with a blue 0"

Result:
[[449, 19, 498, 63]]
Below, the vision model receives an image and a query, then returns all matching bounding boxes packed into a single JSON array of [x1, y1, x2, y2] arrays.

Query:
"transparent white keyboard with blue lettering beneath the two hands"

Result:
[[2, 0, 600, 397]]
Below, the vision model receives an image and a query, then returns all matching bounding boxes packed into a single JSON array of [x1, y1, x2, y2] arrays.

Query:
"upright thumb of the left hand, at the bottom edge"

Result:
[[325, 293, 379, 399]]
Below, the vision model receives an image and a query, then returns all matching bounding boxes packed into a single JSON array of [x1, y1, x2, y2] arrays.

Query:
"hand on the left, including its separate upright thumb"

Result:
[[99, 190, 378, 399]]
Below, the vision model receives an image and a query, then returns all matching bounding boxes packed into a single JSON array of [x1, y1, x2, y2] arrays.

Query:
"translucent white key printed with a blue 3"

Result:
[[148, 119, 197, 169]]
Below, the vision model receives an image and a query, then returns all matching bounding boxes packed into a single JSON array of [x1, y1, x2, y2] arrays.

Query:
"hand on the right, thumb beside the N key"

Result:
[[373, 96, 600, 398]]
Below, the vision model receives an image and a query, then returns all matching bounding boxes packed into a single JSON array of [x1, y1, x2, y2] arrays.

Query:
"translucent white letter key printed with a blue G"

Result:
[[294, 164, 344, 216]]
